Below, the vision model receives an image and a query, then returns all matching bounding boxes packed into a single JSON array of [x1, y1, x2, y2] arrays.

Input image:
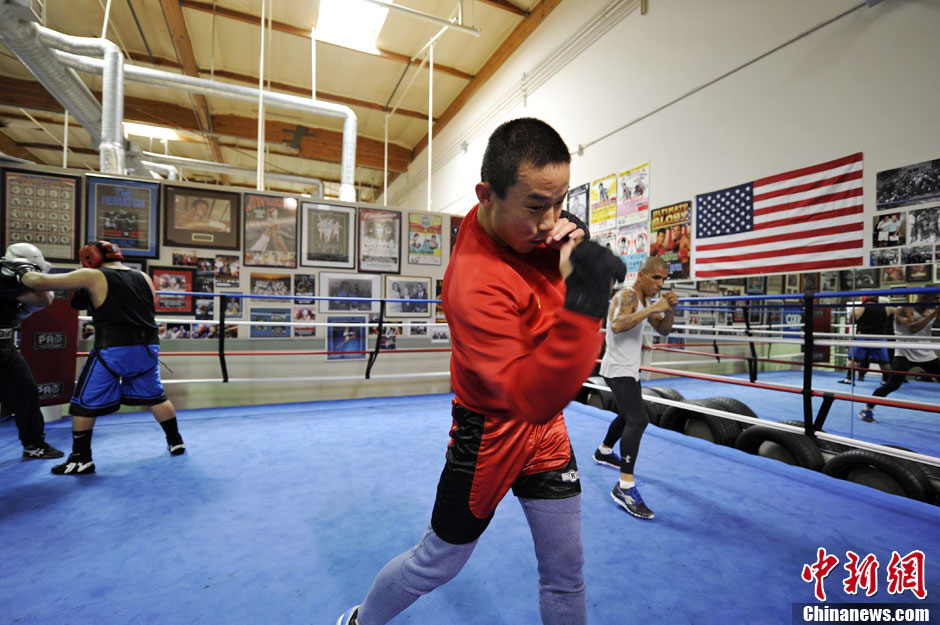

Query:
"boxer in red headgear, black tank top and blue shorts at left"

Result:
[[16, 241, 186, 475]]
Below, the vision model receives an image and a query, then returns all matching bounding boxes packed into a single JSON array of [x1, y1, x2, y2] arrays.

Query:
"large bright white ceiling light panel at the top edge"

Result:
[[317, 0, 388, 54]]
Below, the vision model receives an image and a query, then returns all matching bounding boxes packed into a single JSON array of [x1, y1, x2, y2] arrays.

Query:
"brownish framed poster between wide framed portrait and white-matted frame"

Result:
[[244, 193, 297, 269]]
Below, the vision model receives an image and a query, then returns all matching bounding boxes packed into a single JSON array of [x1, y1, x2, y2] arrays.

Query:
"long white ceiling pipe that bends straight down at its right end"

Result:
[[54, 51, 358, 202]]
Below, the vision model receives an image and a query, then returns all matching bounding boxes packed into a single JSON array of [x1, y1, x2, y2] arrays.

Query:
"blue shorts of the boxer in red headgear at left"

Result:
[[69, 345, 166, 417]]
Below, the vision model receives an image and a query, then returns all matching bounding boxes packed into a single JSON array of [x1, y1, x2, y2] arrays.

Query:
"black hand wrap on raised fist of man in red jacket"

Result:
[[565, 241, 627, 318]]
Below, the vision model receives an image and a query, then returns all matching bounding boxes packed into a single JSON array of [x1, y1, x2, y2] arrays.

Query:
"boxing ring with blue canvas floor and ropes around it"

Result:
[[0, 286, 940, 625]]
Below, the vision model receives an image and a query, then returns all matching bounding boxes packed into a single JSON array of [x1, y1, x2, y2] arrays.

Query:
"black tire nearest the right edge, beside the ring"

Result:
[[823, 449, 934, 503]]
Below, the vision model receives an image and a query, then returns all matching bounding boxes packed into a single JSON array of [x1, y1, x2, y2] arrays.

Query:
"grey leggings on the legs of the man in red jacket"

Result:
[[358, 495, 587, 625]]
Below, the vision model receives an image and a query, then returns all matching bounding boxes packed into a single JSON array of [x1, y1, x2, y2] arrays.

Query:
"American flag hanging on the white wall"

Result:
[[692, 152, 864, 278]]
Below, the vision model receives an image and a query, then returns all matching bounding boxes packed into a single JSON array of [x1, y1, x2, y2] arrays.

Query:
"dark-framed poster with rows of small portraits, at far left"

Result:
[[0, 169, 82, 263]]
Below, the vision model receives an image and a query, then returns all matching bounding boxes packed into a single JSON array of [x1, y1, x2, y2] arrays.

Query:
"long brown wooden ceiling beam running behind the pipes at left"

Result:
[[0, 78, 411, 172]]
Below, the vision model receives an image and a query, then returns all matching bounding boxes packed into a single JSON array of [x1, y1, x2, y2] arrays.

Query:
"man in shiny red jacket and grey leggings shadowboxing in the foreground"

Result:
[[337, 118, 626, 625]]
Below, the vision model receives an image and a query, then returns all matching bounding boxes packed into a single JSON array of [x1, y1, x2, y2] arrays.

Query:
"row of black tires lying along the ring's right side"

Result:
[[620, 386, 940, 505]]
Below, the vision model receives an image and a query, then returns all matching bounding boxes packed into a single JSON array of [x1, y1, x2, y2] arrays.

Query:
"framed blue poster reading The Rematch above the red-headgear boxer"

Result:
[[85, 175, 160, 258]]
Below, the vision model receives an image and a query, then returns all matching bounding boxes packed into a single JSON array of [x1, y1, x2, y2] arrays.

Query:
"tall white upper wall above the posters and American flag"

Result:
[[389, 0, 940, 240]]
